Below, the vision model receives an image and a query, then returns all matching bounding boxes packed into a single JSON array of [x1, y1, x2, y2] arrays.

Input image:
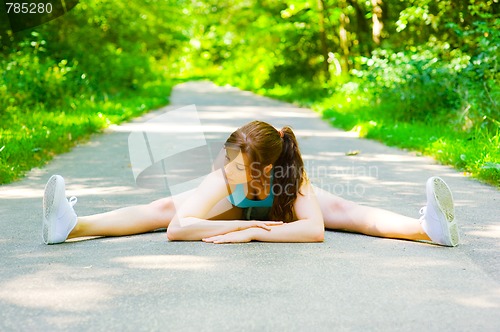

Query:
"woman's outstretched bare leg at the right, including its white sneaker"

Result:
[[315, 177, 459, 246]]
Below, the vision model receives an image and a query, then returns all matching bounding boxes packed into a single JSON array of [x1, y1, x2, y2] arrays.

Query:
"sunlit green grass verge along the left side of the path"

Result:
[[0, 80, 178, 184]]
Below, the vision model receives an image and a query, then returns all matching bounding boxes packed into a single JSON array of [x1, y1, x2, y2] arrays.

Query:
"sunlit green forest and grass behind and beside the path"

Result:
[[0, 0, 500, 187]]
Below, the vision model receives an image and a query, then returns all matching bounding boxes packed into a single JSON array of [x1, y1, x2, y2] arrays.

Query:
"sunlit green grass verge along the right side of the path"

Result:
[[256, 86, 500, 188]]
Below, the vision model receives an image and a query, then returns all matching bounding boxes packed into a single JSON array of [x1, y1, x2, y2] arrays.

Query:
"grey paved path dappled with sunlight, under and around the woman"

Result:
[[0, 82, 500, 331]]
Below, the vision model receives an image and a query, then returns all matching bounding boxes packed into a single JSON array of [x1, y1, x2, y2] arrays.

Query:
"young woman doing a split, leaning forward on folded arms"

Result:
[[42, 121, 459, 246]]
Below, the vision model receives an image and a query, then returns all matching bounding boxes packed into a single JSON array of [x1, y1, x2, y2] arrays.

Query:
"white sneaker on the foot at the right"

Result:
[[420, 176, 460, 247]]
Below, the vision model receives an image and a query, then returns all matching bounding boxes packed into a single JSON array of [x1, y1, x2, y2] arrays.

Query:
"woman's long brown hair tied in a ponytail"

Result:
[[225, 121, 306, 222]]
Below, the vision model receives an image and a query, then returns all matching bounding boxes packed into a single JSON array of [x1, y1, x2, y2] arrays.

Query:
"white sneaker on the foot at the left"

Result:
[[42, 175, 77, 244]]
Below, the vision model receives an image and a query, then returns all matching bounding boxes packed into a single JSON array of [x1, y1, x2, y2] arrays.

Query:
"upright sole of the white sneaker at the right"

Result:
[[432, 177, 460, 247]]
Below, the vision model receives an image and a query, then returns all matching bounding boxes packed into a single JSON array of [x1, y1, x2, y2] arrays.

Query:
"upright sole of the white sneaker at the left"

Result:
[[42, 175, 64, 244]]
